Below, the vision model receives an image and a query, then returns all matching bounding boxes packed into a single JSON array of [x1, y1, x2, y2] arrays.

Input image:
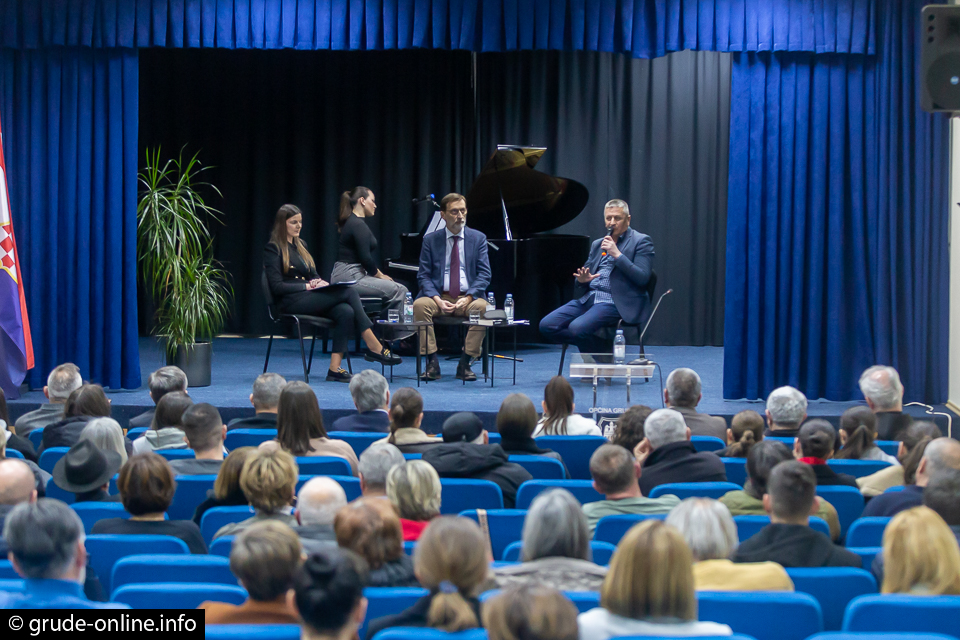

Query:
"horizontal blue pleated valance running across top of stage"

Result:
[[0, 0, 877, 58]]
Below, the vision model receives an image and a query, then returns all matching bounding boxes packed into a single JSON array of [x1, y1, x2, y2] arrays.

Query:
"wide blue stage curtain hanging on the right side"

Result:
[[724, 0, 949, 402]]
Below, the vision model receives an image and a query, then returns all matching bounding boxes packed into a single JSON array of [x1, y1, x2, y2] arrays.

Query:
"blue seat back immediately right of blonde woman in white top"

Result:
[[697, 591, 823, 640]]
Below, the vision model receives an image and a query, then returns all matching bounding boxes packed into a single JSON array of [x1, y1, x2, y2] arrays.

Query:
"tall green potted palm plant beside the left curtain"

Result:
[[137, 148, 233, 387]]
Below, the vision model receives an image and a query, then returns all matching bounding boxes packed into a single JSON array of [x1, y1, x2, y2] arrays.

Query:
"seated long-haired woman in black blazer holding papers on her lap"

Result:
[[263, 204, 401, 382]]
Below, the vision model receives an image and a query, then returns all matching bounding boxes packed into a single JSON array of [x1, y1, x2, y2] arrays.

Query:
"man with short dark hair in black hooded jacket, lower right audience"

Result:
[[733, 460, 863, 567]]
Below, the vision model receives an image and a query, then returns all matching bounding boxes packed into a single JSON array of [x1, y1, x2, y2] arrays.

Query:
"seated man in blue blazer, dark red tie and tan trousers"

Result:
[[413, 193, 490, 380]]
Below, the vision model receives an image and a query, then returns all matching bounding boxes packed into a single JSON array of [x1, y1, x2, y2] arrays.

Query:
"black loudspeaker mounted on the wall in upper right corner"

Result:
[[920, 4, 960, 112]]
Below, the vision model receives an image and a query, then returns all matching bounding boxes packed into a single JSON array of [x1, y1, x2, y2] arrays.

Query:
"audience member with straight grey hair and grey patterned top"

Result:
[[495, 492, 612, 591]]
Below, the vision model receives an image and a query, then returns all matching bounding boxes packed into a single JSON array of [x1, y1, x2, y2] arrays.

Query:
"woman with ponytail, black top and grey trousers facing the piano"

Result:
[[330, 187, 407, 309]]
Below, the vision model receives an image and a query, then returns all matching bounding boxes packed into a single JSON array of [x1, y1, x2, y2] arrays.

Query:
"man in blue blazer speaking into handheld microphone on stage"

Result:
[[540, 200, 654, 353]]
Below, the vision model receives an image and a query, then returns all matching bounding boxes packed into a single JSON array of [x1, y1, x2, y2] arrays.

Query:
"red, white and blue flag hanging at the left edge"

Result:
[[0, 119, 33, 399]]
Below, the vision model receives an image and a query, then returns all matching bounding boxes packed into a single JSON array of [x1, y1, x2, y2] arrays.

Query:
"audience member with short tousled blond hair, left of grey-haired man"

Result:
[[213, 449, 299, 538]]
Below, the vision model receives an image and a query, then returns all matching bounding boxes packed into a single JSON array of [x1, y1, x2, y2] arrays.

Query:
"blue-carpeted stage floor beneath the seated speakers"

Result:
[[9, 338, 948, 432]]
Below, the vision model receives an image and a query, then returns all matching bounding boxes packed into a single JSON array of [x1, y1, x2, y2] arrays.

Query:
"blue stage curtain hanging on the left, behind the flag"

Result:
[[0, 48, 140, 388]]
